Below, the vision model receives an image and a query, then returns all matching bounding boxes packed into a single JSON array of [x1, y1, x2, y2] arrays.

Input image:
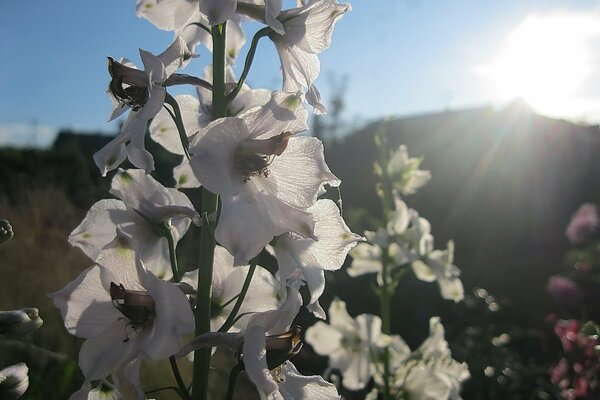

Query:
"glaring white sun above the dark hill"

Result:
[[488, 15, 600, 116]]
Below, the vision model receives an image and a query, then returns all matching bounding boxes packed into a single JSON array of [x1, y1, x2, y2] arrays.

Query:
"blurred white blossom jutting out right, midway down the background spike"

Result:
[[411, 241, 464, 302]]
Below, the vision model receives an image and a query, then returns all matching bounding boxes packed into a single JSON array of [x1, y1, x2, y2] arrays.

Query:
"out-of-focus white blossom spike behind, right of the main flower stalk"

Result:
[[306, 143, 470, 400]]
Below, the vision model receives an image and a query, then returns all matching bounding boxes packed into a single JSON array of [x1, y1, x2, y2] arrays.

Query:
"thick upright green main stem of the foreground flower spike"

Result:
[[192, 24, 227, 400]]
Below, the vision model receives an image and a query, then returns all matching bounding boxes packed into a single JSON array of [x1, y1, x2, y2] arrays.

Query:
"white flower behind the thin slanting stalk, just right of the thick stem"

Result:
[[182, 246, 279, 332]]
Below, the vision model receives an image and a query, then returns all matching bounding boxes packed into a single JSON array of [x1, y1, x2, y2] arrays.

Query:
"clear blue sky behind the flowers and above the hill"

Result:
[[0, 0, 600, 145]]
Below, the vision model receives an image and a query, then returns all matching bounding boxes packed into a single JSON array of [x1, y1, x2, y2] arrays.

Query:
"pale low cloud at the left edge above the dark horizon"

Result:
[[0, 122, 58, 148]]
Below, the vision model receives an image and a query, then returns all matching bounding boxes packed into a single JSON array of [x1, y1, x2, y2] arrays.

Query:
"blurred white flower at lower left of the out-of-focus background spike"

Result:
[[306, 300, 388, 390]]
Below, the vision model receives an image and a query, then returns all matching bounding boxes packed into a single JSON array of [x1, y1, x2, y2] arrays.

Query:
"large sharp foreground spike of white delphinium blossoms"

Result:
[[50, 0, 363, 400]]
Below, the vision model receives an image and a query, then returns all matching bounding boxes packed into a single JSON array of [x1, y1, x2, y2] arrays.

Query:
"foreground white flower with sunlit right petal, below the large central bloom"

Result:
[[273, 199, 364, 319]]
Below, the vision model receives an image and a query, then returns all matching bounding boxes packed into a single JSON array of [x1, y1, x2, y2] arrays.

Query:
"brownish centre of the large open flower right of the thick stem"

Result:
[[234, 132, 292, 183]]
